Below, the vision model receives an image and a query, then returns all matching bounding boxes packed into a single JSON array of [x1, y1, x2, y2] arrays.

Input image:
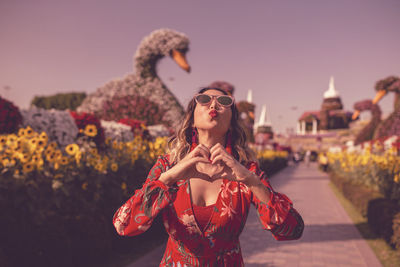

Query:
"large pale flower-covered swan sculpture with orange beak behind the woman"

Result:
[[77, 29, 190, 127]]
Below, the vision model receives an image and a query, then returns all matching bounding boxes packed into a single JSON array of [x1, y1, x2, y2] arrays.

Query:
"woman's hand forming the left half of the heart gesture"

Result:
[[159, 144, 210, 186]]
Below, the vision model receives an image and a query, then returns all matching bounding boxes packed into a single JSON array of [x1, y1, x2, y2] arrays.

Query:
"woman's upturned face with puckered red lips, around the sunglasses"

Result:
[[193, 89, 232, 134]]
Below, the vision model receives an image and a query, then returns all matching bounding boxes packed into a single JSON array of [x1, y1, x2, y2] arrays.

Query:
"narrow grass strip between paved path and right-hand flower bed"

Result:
[[329, 182, 400, 267]]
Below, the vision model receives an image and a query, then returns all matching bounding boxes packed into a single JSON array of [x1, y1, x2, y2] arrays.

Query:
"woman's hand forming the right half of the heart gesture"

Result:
[[210, 143, 259, 185]]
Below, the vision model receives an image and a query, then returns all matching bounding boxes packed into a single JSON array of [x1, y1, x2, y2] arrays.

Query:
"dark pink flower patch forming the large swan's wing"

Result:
[[103, 95, 166, 125]]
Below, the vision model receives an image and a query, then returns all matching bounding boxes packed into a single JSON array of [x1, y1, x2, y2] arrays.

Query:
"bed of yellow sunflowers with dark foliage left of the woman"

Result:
[[0, 128, 166, 266]]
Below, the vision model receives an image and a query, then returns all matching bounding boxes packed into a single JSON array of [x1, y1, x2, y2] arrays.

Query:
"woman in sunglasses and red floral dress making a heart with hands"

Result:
[[113, 88, 304, 266]]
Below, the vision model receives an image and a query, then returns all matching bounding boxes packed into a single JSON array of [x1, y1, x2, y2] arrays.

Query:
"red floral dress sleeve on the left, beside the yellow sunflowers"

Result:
[[113, 156, 177, 236]]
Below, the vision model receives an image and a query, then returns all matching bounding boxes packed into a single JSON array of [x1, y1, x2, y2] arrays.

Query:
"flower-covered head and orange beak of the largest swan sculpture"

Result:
[[134, 29, 190, 72]]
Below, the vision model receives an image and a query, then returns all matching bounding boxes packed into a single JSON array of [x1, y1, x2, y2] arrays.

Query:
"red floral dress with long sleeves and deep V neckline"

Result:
[[113, 155, 304, 267]]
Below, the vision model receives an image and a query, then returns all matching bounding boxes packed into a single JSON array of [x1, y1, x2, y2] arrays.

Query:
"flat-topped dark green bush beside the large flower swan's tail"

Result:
[[31, 93, 86, 110]]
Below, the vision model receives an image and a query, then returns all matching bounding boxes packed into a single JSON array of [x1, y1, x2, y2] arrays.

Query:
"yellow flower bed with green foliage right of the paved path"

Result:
[[327, 136, 400, 251]]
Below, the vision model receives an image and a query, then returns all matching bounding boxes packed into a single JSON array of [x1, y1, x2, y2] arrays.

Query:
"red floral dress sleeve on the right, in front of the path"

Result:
[[249, 162, 304, 240]]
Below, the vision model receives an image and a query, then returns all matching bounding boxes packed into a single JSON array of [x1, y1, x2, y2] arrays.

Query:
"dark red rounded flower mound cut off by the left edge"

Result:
[[0, 97, 22, 134]]
